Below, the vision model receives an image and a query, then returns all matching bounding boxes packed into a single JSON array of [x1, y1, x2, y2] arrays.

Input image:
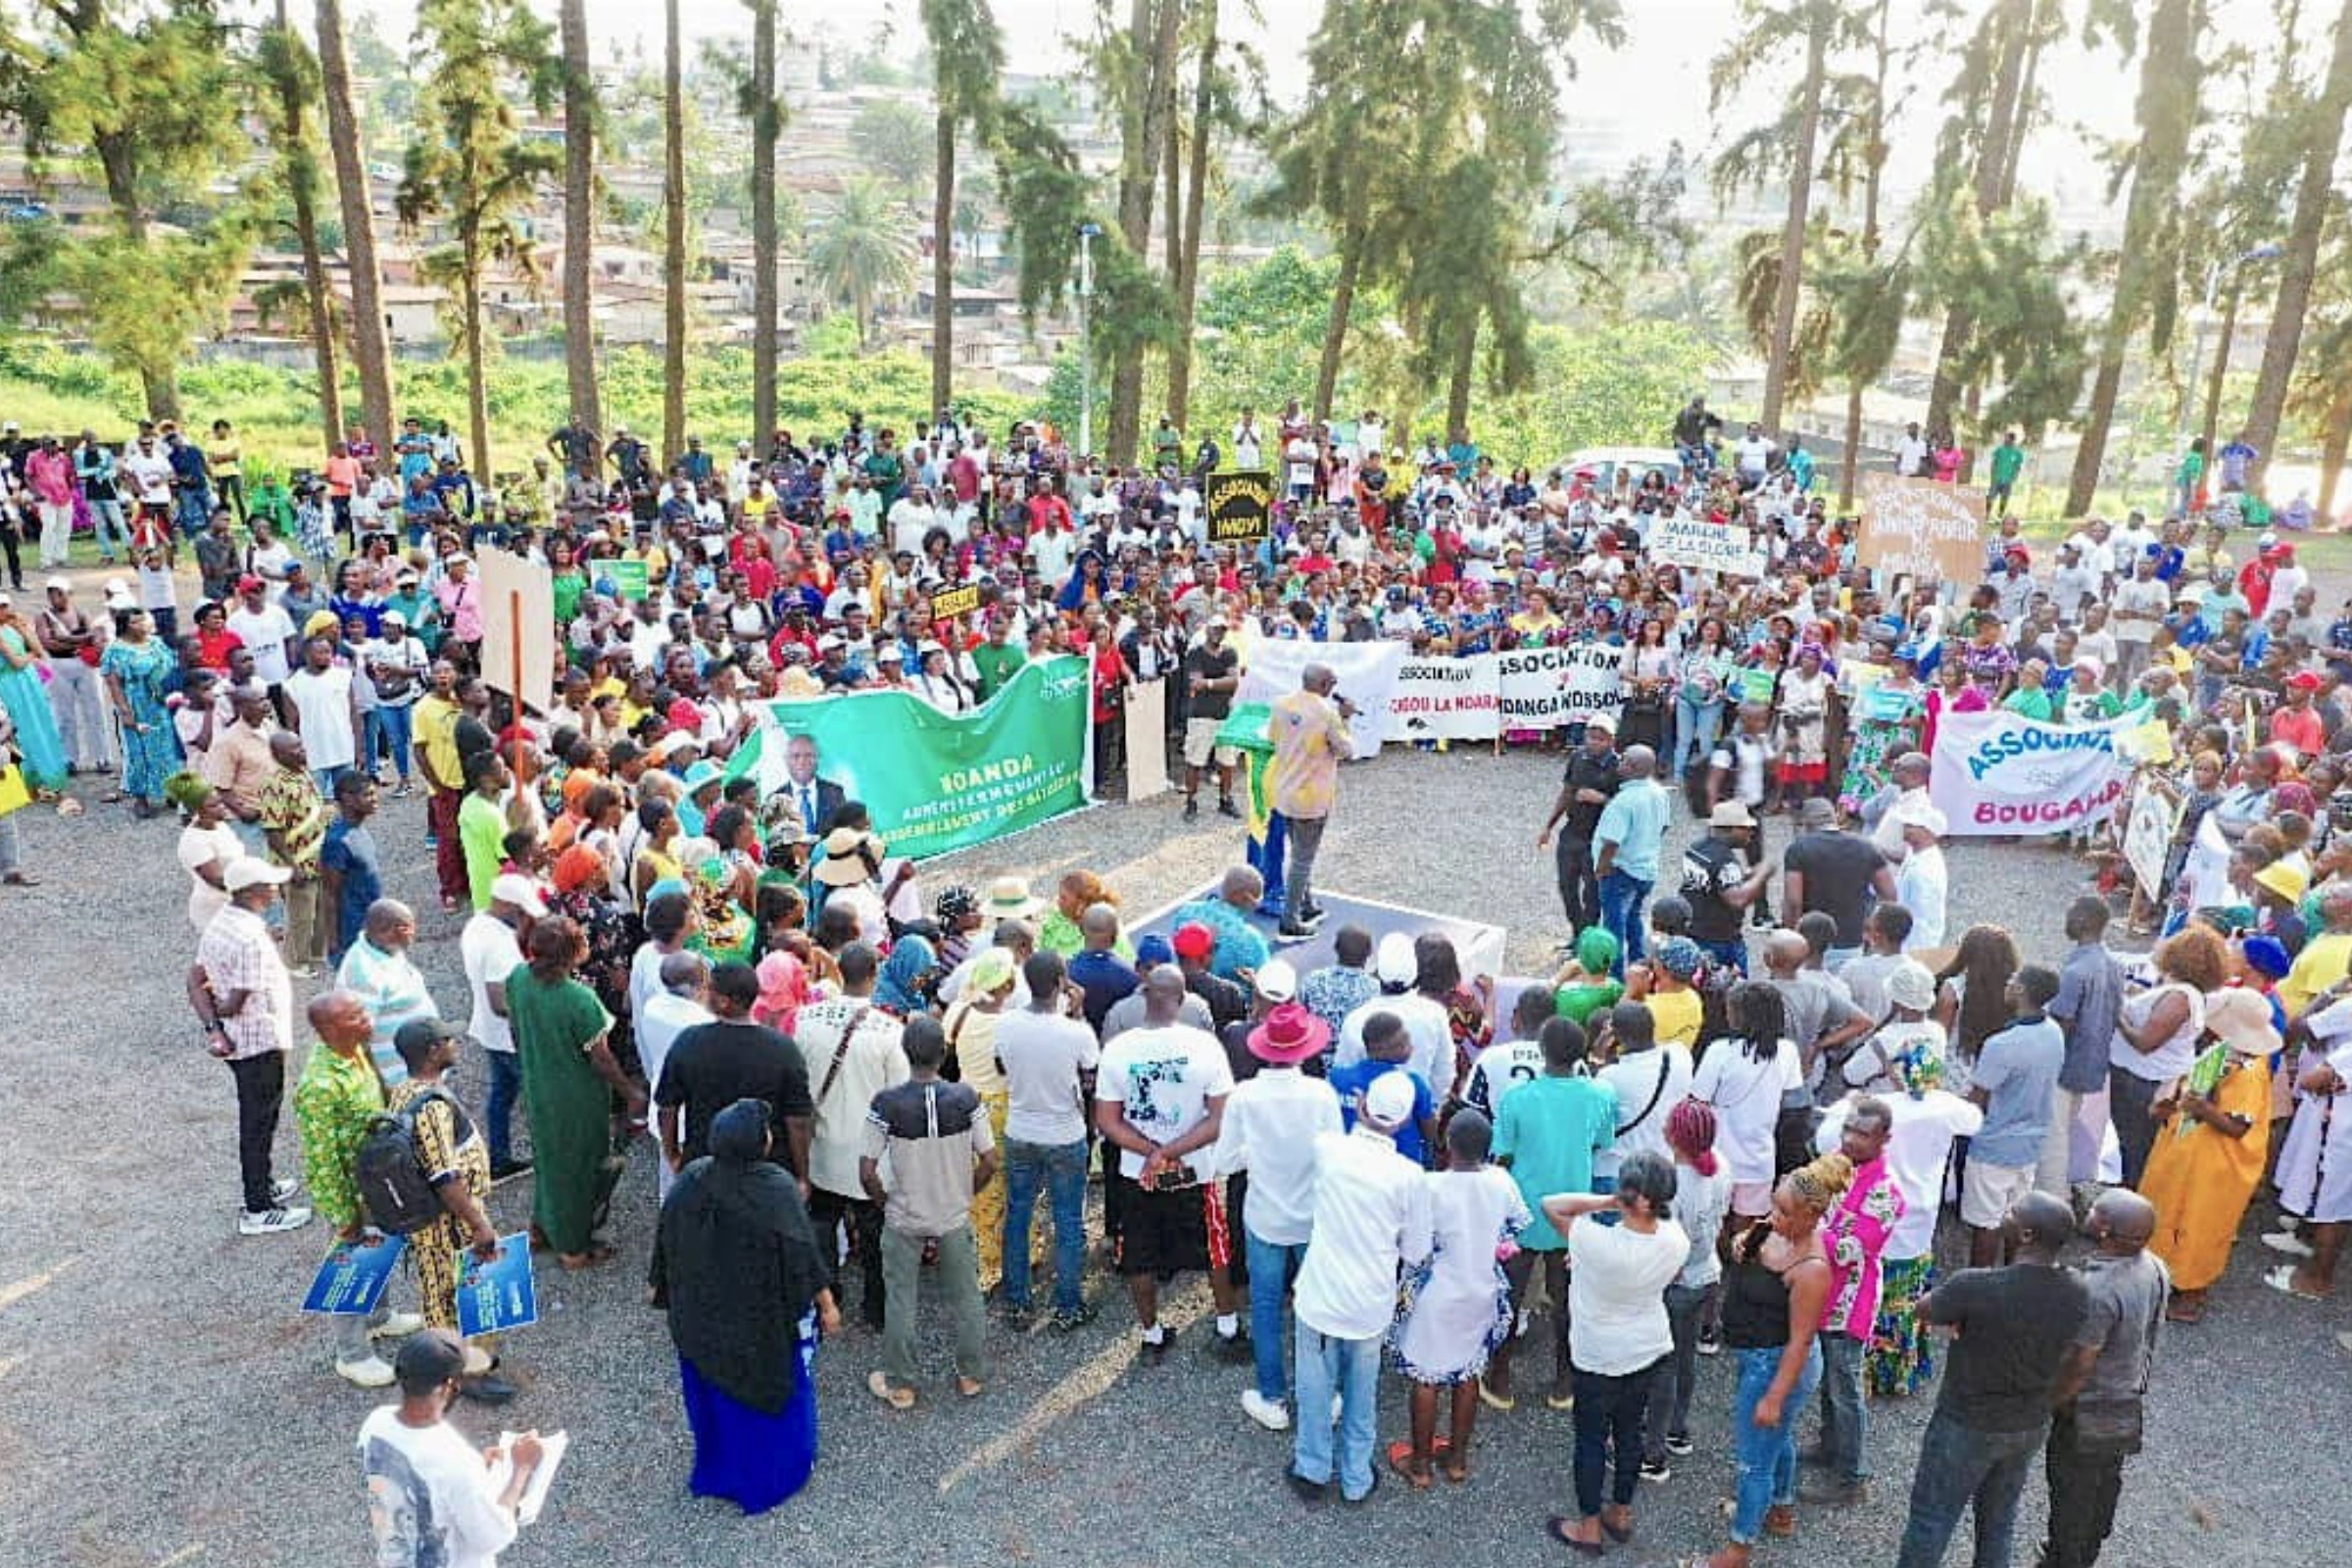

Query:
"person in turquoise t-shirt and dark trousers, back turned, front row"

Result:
[[1482, 1018, 1618, 1410]]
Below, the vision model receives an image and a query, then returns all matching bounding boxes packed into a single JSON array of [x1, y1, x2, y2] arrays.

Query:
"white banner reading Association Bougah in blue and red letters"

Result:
[[1929, 710, 2145, 837]]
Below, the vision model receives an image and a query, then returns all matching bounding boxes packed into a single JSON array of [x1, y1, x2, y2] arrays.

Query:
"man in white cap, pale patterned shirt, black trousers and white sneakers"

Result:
[[188, 856, 311, 1237]]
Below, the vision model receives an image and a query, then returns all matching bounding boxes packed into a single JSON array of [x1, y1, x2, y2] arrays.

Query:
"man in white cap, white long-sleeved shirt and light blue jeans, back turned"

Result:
[[1289, 1072, 1430, 1502]]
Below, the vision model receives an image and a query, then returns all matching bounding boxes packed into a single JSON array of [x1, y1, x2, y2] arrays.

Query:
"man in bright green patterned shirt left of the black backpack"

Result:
[[294, 990, 425, 1390]]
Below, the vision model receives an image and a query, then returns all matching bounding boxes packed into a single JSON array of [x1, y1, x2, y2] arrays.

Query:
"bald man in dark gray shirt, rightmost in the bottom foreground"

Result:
[[2041, 1187, 2171, 1568]]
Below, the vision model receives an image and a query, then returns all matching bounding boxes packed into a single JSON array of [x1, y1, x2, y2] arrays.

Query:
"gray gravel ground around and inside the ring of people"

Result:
[[0, 748, 2352, 1568]]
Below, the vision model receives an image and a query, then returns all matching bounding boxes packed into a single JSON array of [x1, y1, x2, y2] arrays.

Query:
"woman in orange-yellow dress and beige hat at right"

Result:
[[2140, 990, 2279, 1324]]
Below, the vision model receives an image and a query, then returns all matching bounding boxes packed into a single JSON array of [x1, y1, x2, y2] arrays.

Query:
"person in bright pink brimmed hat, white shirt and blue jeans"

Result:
[[1213, 1002, 1343, 1432]]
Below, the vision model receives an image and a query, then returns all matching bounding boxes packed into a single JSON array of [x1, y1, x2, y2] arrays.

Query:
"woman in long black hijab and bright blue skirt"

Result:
[[652, 1101, 842, 1514]]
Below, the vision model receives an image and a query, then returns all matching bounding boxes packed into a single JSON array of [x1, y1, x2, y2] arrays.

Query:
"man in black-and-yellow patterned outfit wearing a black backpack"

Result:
[[390, 1018, 515, 1405]]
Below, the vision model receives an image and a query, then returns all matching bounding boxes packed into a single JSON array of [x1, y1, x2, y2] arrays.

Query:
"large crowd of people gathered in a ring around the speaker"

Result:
[[0, 402, 2352, 1568]]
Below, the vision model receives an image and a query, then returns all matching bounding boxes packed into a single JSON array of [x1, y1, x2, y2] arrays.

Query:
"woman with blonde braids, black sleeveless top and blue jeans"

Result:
[[1700, 1154, 1853, 1568]]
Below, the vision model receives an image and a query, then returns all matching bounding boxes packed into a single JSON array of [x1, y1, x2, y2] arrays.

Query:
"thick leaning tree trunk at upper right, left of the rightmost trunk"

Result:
[[2065, 0, 2206, 517]]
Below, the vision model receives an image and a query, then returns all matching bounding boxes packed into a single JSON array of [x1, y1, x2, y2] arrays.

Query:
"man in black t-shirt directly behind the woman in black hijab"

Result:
[[654, 964, 816, 1180]]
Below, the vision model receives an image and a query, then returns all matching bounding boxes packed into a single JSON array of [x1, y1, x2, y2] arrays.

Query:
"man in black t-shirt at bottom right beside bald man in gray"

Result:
[[1895, 1192, 2091, 1568]]
